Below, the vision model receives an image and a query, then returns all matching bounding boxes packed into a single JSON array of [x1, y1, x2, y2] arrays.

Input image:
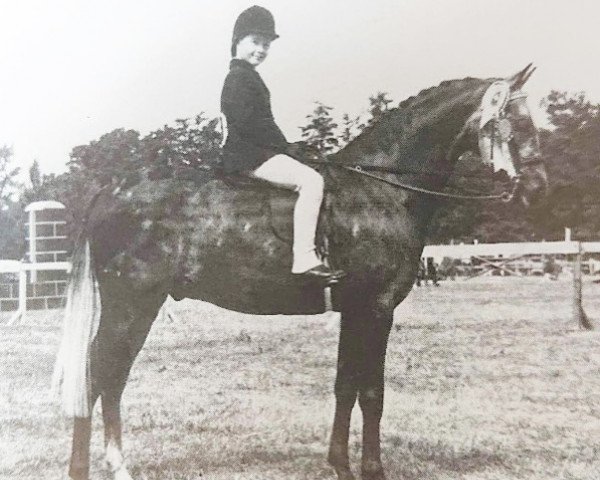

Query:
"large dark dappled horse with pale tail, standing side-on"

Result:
[[55, 67, 547, 480]]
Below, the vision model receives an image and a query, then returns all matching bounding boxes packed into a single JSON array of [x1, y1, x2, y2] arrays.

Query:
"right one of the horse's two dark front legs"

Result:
[[358, 313, 393, 480]]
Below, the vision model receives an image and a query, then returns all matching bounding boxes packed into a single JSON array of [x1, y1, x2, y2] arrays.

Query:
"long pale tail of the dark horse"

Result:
[[52, 239, 101, 417]]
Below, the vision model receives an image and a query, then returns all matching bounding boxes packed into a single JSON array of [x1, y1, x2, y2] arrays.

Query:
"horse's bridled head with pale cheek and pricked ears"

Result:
[[472, 64, 548, 205]]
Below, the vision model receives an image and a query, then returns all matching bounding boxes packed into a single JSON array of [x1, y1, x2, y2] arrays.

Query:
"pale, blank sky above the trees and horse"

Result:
[[0, 0, 600, 180]]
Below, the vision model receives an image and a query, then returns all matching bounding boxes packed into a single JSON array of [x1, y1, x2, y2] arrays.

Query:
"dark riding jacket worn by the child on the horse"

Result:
[[221, 58, 288, 172]]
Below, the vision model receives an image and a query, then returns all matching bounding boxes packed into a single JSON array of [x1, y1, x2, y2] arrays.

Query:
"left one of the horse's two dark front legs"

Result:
[[328, 309, 361, 480]]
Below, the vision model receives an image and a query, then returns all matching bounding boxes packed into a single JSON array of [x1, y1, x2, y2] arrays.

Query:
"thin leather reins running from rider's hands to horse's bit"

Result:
[[303, 159, 519, 203]]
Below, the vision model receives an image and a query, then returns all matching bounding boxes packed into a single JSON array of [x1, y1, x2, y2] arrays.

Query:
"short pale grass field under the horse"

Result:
[[0, 278, 600, 480]]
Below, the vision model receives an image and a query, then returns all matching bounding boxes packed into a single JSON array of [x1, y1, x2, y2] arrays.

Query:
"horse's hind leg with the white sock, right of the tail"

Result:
[[98, 284, 164, 480]]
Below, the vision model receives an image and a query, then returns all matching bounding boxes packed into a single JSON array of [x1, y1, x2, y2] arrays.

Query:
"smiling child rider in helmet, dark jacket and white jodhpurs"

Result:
[[221, 5, 343, 281]]
